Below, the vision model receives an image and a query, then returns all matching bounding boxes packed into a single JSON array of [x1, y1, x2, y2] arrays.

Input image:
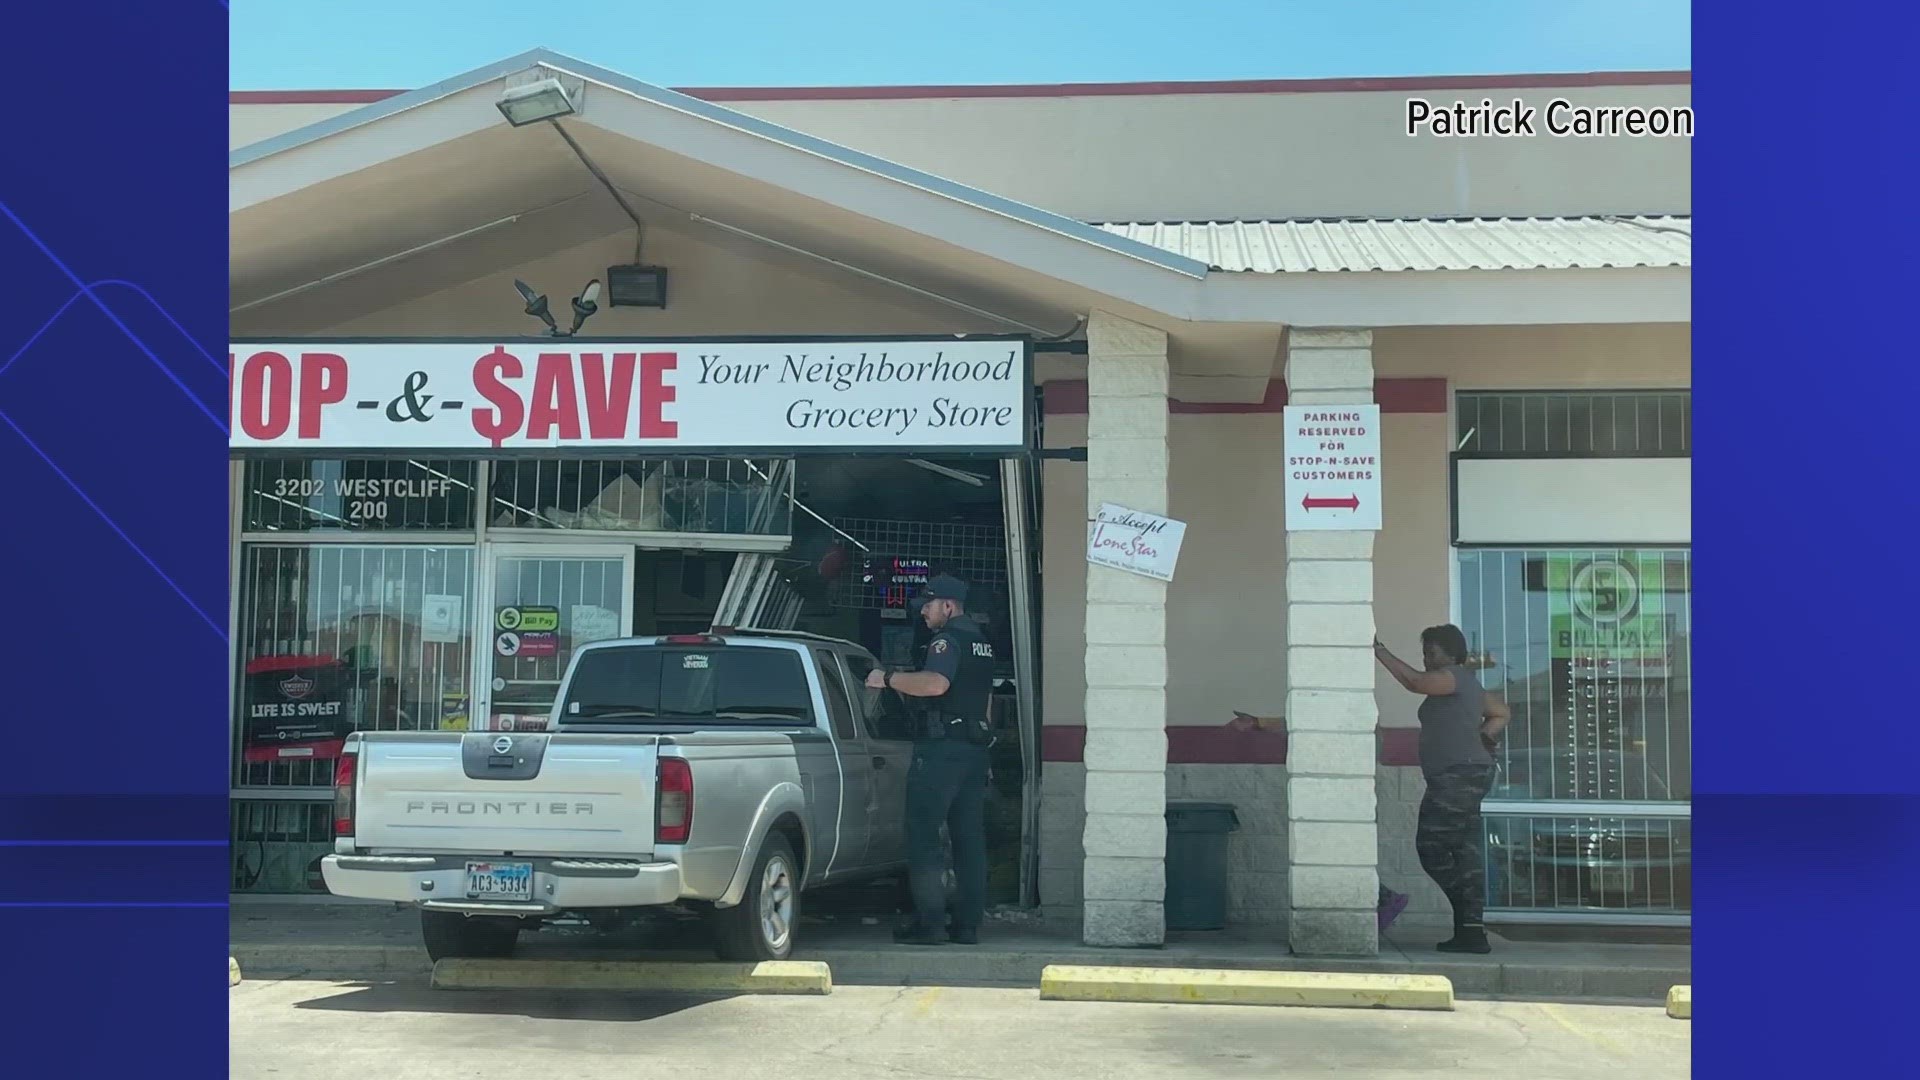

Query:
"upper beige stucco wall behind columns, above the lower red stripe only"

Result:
[[1043, 325, 1693, 726]]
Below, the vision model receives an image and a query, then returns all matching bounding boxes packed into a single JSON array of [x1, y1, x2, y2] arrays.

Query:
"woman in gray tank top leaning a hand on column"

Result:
[[1373, 625, 1511, 953]]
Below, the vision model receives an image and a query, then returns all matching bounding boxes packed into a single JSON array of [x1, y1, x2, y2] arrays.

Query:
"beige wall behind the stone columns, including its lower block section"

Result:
[[1041, 327, 1692, 922]]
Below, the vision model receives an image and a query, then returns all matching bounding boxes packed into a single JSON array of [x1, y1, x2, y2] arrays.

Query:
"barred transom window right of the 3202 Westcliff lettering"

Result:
[[488, 457, 793, 536]]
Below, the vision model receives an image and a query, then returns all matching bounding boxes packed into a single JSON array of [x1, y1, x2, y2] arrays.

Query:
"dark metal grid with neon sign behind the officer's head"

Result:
[[833, 517, 1006, 609]]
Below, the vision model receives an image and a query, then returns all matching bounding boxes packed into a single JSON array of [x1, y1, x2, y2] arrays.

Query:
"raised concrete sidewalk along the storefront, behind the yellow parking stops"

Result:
[[228, 897, 1693, 1005]]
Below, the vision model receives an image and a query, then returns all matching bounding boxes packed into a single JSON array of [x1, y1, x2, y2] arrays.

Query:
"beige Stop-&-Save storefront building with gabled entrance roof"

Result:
[[230, 52, 1692, 953]]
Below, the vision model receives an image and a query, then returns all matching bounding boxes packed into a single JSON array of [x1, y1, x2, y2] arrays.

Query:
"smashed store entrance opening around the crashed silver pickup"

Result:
[[560, 455, 1037, 905]]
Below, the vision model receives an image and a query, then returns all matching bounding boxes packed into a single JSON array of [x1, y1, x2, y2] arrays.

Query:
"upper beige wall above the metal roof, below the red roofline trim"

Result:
[[228, 71, 1693, 221]]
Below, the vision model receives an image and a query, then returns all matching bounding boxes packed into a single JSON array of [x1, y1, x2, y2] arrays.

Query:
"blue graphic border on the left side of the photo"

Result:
[[0, 2, 230, 1076]]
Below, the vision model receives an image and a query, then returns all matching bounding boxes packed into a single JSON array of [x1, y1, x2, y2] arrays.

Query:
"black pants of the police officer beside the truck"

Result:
[[906, 738, 991, 930]]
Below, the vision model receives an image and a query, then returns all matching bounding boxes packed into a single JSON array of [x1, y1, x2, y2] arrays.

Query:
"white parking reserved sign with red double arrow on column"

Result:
[[1283, 405, 1380, 532]]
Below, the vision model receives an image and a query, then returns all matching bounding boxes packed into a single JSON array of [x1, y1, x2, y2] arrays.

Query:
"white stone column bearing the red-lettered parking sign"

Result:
[[1286, 327, 1380, 955]]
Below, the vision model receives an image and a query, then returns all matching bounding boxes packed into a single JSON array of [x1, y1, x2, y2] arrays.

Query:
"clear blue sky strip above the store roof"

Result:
[[228, 0, 1693, 90]]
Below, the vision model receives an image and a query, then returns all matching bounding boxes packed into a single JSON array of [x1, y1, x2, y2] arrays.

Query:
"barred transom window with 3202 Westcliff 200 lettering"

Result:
[[240, 457, 480, 532]]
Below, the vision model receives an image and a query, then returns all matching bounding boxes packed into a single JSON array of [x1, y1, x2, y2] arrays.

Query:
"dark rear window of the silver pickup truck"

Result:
[[561, 646, 814, 723]]
